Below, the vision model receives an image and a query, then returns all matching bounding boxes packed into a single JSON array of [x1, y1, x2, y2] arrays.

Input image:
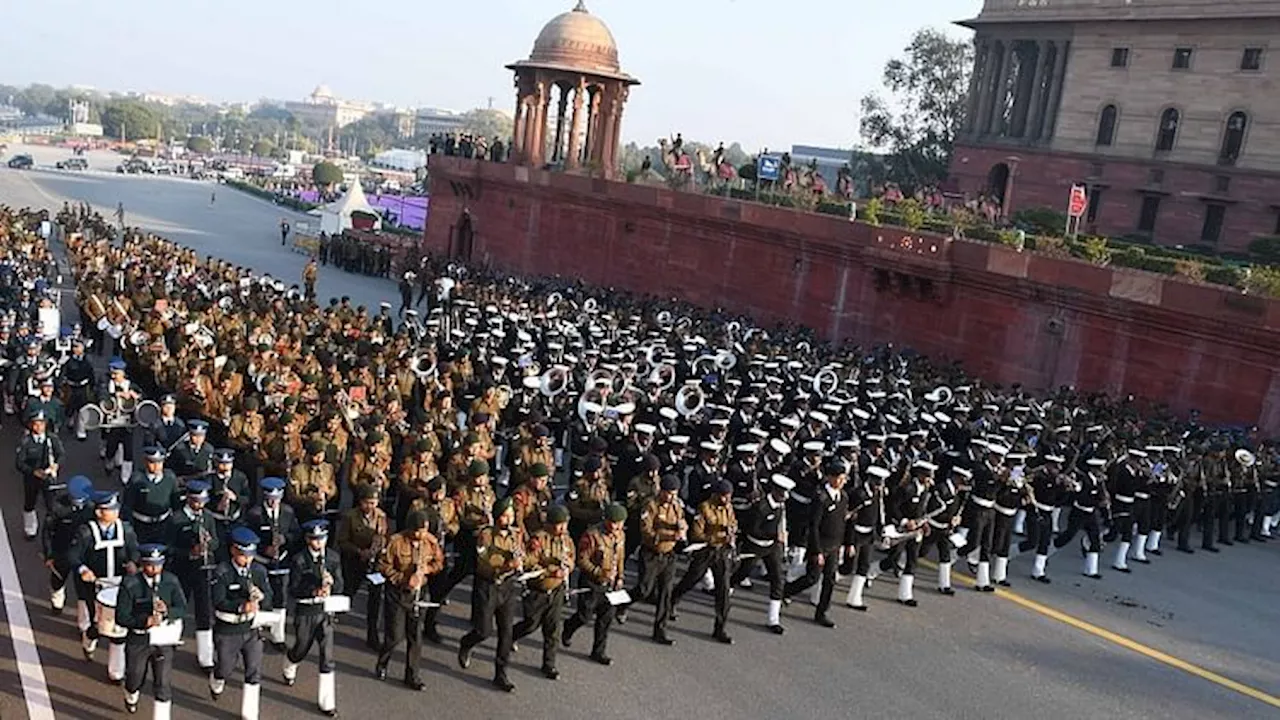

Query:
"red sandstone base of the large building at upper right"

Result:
[[951, 146, 1280, 252]]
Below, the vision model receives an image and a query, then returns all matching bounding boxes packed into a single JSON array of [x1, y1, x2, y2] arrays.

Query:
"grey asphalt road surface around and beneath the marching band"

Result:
[[0, 158, 1280, 720]]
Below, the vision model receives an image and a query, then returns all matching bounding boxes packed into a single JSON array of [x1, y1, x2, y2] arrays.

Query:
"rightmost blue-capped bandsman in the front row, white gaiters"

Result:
[[284, 520, 343, 717]]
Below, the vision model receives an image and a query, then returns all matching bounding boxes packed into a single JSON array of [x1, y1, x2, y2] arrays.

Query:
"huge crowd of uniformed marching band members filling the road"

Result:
[[0, 199, 1280, 717]]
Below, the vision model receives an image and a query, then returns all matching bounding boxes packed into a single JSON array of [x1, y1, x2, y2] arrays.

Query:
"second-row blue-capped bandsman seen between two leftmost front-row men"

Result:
[[163, 480, 221, 673]]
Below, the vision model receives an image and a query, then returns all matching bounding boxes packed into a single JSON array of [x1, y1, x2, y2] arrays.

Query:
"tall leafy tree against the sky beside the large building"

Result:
[[859, 28, 973, 191]]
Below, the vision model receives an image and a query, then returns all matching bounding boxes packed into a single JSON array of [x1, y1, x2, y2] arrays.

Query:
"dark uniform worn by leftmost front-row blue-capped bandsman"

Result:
[[115, 573, 187, 702]]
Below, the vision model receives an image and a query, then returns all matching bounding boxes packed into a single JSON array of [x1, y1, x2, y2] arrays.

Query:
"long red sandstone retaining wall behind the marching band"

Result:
[[425, 156, 1280, 430]]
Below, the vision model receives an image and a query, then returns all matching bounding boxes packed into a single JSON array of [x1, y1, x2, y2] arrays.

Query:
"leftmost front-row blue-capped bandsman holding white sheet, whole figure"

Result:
[[115, 544, 187, 720]]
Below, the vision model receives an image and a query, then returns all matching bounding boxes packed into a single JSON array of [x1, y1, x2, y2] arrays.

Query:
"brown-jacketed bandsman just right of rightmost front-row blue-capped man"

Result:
[[338, 486, 390, 650]]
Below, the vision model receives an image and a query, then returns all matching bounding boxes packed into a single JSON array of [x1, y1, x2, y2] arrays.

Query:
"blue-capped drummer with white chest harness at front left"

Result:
[[67, 491, 138, 682]]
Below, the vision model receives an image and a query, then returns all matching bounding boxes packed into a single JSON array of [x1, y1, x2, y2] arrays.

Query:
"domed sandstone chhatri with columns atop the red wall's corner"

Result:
[[507, 0, 640, 178]]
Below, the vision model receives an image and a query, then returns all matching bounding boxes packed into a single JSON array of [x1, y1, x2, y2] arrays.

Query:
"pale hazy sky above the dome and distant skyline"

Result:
[[0, 0, 982, 150]]
